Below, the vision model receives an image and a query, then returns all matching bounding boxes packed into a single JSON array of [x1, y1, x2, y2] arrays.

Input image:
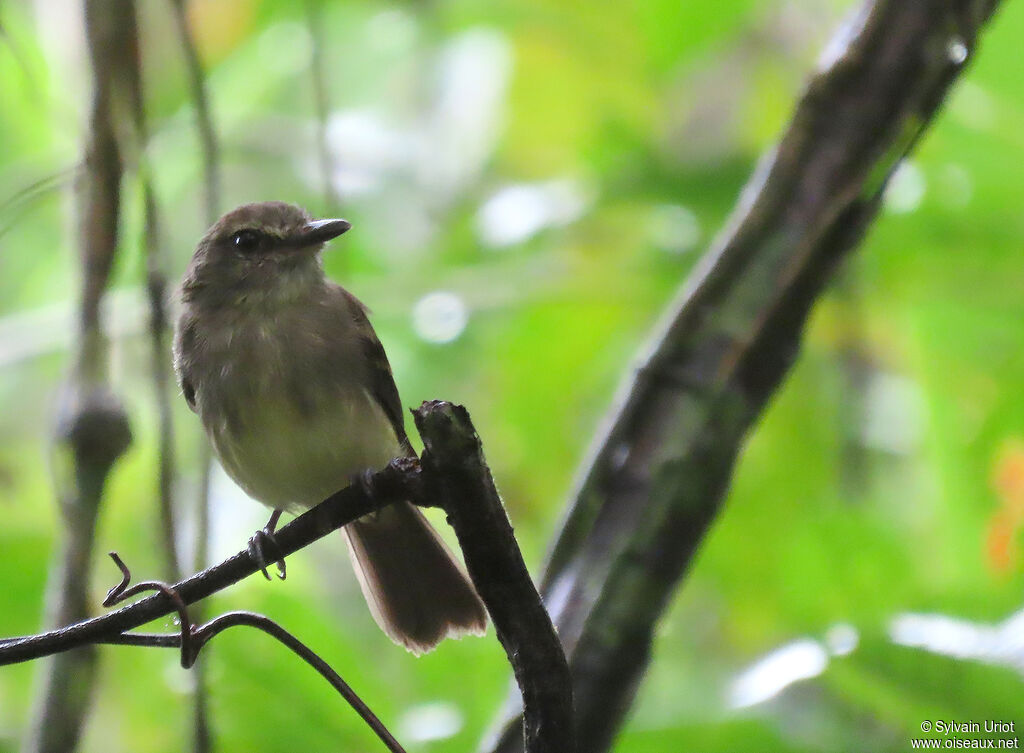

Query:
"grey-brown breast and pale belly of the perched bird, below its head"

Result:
[[190, 311, 401, 508]]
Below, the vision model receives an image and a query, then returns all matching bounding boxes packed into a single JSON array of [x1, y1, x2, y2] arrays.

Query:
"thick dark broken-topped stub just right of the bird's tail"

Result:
[[413, 401, 575, 753]]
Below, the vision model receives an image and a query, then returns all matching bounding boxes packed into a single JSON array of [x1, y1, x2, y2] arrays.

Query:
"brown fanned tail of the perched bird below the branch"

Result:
[[342, 502, 487, 655]]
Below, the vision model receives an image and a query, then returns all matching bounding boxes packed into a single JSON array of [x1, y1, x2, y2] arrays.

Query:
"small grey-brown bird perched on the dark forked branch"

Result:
[[173, 201, 487, 655]]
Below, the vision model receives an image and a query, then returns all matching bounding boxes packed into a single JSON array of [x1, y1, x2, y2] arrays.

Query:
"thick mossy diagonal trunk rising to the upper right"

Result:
[[495, 0, 996, 753]]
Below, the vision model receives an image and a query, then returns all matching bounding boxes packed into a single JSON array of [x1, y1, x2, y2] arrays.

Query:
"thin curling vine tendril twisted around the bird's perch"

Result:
[[102, 552, 406, 753]]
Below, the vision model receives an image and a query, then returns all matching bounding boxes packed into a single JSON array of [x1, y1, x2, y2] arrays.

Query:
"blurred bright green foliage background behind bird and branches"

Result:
[[0, 0, 1024, 753]]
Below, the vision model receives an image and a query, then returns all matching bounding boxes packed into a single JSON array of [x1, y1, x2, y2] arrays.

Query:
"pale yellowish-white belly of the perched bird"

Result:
[[206, 385, 402, 510]]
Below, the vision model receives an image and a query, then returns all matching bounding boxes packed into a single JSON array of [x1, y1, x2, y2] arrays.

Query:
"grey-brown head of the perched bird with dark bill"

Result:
[[181, 202, 351, 306]]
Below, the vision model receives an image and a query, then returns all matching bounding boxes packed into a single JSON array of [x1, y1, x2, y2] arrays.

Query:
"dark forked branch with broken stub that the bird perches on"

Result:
[[0, 402, 574, 753]]
